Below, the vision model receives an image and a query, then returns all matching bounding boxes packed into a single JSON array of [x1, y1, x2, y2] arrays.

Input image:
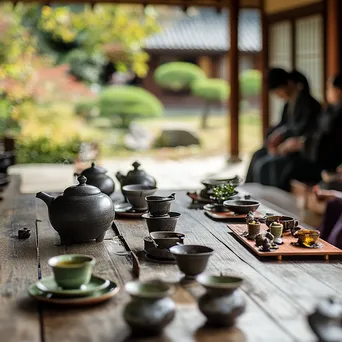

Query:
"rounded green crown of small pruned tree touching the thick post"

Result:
[[191, 78, 230, 101]]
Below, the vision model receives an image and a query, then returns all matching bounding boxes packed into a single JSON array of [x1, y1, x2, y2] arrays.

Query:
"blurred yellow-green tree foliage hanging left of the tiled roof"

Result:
[[38, 5, 159, 82]]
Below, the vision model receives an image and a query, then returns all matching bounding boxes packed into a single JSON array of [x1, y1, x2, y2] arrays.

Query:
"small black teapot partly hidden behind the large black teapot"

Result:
[[75, 163, 115, 196]]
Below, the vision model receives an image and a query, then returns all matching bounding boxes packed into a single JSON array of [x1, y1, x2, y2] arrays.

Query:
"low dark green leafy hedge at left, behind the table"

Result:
[[16, 137, 81, 164]]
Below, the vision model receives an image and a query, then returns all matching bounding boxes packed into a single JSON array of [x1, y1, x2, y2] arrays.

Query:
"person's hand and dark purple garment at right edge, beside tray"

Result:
[[314, 183, 342, 248]]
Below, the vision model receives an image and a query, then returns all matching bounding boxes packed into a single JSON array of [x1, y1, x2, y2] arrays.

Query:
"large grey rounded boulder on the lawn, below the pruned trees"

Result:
[[155, 129, 200, 147]]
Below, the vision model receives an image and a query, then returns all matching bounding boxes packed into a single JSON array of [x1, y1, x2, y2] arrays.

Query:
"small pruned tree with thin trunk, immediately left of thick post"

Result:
[[191, 78, 230, 129]]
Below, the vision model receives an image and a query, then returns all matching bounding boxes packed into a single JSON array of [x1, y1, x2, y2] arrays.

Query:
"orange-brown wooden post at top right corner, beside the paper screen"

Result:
[[325, 0, 342, 78]]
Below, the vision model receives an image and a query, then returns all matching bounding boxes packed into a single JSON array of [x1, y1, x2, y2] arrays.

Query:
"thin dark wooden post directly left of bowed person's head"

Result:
[[260, 0, 270, 137]]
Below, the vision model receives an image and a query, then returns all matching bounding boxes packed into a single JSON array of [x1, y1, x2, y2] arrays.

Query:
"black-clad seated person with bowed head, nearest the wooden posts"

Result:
[[246, 68, 321, 184]]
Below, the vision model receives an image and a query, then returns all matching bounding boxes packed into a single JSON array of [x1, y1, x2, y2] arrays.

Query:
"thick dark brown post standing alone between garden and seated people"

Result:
[[228, 0, 240, 162]]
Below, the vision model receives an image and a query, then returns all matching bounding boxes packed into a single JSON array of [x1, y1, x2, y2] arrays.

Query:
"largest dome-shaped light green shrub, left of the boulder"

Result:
[[98, 86, 164, 128]]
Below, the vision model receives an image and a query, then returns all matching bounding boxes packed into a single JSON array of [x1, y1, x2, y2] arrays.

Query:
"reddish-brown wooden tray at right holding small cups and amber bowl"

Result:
[[228, 224, 342, 260]]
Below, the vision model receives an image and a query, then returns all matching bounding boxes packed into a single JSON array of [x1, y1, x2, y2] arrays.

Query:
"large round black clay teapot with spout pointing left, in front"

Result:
[[36, 175, 115, 244]]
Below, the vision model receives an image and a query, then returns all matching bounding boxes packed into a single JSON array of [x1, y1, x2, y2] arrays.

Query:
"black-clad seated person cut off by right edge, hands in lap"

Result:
[[268, 74, 342, 190]]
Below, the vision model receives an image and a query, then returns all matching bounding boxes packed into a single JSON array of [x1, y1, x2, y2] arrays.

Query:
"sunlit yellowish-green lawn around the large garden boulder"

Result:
[[94, 111, 262, 159]]
